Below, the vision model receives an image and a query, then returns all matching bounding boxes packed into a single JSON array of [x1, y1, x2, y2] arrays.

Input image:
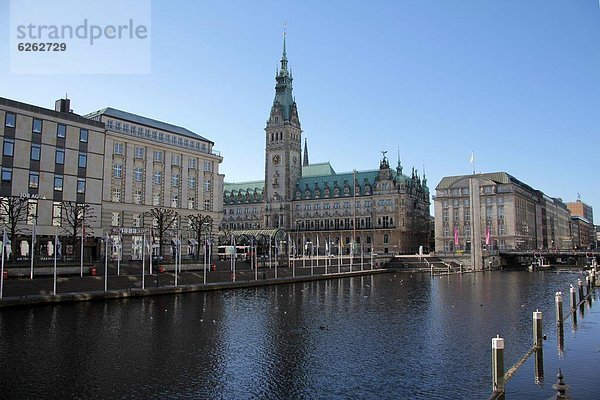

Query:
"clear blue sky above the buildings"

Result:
[[0, 0, 600, 221]]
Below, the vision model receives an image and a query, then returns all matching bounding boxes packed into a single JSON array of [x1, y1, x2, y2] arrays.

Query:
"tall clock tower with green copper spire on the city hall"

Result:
[[264, 32, 302, 230]]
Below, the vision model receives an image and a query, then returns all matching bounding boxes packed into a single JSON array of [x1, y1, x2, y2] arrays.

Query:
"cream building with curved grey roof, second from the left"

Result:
[[85, 107, 223, 260]]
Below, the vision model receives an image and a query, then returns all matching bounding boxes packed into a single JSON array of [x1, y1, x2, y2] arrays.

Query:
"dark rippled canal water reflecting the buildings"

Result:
[[0, 272, 600, 399]]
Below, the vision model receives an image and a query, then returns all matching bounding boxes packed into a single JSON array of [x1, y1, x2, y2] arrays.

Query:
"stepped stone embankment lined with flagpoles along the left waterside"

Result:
[[0, 263, 389, 308]]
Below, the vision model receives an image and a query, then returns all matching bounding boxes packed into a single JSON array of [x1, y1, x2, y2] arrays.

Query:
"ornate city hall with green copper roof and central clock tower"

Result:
[[221, 37, 430, 254]]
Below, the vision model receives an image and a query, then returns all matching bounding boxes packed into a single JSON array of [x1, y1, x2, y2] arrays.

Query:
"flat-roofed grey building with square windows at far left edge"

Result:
[[0, 98, 105, 258]]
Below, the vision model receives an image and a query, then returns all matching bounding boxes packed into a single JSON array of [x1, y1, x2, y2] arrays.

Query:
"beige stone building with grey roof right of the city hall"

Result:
[[434, 172, 572, 253]]
